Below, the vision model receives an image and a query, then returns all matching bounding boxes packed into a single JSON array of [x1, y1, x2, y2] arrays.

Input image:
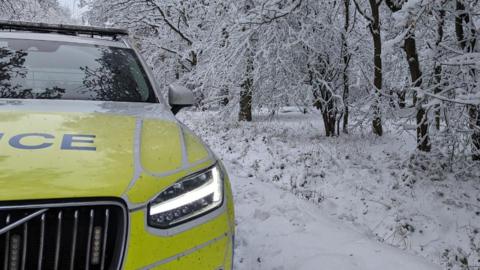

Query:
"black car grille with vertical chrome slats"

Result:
[[0, 202, 127, 270]]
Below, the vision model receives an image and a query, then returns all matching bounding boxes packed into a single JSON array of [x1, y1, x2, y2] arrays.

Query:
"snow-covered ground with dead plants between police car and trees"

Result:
[[179, 109, 480, 270]]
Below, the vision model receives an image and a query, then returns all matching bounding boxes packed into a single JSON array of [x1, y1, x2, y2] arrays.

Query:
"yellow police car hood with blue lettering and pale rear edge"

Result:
[[0, 100, 211, 201]]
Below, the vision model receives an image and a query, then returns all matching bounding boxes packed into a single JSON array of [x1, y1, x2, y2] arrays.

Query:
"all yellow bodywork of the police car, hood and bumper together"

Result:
[[0, 107, 234, 270]]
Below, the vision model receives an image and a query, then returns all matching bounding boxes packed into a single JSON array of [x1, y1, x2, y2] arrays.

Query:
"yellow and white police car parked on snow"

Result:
[[0, 22, 234, 270]]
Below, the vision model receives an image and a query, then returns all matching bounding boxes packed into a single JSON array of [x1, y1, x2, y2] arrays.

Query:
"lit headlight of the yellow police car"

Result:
[[148, 166, 223, 229]]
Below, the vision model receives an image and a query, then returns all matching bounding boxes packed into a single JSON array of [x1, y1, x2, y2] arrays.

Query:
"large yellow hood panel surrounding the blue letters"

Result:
[[0, 110, 135, 200]]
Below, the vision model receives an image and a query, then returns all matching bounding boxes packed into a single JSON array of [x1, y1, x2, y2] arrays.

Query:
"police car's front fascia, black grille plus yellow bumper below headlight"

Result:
[[0, 189, 234, 270]]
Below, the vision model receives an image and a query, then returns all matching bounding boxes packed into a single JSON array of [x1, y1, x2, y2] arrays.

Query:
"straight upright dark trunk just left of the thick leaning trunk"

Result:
[[369, 0, 383, 136]]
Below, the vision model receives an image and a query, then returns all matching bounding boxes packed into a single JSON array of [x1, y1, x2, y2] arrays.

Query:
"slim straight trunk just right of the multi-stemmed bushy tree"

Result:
[[342, 0, 350, 134]]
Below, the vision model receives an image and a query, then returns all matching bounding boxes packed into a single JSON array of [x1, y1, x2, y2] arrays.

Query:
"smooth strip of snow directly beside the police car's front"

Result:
[[231, 168, 440, 270]]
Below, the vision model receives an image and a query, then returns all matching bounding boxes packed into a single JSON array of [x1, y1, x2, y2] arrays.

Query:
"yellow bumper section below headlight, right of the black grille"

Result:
[[123, 207, 234, 270]]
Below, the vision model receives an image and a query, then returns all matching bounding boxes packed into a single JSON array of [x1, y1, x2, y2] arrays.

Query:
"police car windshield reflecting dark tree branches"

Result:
[[0, 39, 158, 103]]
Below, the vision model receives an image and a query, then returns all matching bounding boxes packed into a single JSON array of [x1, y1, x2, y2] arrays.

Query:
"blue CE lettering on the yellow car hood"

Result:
[[0, 132, 97, 151]]
